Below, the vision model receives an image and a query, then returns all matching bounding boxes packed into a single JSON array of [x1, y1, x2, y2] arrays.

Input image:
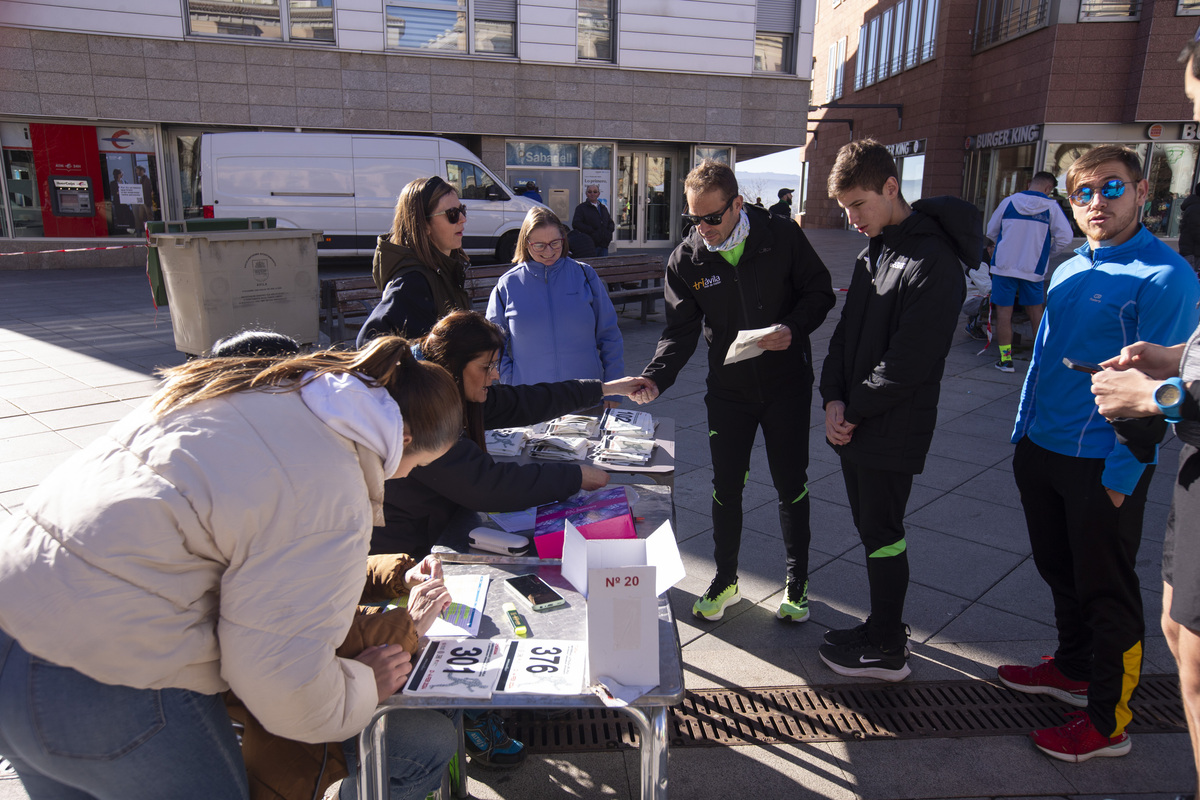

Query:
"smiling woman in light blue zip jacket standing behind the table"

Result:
[[487, 207, 625, 408]]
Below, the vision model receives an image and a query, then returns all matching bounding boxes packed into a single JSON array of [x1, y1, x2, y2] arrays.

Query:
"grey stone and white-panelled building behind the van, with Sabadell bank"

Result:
[[0, 0, 815, 269]]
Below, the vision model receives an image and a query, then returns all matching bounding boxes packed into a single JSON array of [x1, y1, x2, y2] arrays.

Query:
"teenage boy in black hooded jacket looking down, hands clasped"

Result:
[[821, 139, 983, 681]]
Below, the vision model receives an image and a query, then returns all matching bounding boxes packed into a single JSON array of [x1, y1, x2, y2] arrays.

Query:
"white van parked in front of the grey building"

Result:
[[200, 131, 541, 263]]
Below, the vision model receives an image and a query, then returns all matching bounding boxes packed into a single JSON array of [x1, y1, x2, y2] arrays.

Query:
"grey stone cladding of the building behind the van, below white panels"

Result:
[[0, 26, 808, 271]]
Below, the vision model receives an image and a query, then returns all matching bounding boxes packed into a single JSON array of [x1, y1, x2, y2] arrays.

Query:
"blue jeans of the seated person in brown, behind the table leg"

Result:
[[337, 709, 462, 800]]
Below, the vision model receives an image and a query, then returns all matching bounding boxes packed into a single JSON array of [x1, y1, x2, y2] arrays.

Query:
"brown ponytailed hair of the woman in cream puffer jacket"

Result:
[[151, 336, 462, 451]]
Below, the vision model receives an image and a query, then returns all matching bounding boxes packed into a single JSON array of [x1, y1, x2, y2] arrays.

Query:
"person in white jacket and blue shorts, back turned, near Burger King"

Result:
[[988, 173, 1072, 372]]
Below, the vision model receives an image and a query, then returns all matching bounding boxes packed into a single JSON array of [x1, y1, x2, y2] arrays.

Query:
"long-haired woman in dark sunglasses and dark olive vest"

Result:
[[358, 175, 470, 348]]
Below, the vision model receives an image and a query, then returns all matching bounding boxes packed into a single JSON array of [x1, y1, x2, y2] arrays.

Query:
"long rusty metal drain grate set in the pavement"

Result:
[[506, 675, 1187, 753]]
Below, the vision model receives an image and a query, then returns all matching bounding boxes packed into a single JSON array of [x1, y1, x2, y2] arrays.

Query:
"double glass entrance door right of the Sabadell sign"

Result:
[[616, 152, 677, 246]]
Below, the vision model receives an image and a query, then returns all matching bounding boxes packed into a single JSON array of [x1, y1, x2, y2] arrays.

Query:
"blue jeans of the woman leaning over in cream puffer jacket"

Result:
[[0, 630, 250, 800]]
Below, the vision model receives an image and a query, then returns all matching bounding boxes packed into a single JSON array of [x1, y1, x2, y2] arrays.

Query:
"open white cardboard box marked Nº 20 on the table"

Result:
[[563, 522, 685, 687]]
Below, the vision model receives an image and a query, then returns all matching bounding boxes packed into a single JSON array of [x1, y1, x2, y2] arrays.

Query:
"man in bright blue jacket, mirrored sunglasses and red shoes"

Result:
[[998, 145, 1200, 762]]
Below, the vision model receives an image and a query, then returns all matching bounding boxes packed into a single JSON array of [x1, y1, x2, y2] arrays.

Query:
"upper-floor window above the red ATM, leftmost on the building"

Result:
[[187, 0, 334, 44]]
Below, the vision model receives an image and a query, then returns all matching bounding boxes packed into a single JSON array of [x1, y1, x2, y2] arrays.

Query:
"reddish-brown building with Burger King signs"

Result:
[[803, 0, 1200, 237]]
